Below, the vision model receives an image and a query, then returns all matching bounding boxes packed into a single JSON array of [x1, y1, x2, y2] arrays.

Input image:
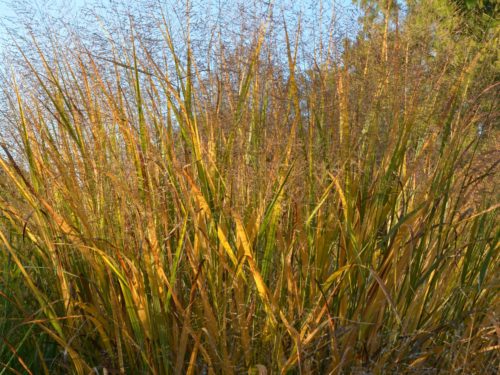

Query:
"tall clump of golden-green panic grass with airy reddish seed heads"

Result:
[[0, 2, 500, 374]]
